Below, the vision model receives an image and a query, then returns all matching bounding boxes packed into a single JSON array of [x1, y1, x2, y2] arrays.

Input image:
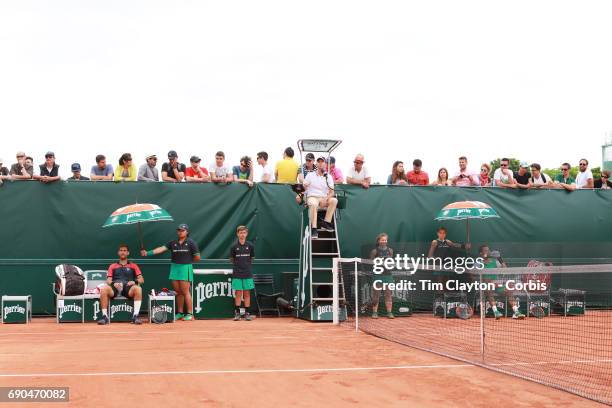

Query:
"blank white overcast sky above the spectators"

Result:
[[0, 0, 612, 182]]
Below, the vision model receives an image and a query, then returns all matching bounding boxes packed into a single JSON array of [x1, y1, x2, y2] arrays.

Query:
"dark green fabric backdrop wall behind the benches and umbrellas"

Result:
[[0, 182, 612, 313]]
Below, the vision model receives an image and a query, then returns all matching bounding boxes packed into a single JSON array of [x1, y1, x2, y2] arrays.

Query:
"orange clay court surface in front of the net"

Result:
[[0, 318, 603, 408]]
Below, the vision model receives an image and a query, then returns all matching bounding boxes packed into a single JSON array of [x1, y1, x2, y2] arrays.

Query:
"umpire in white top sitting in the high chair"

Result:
[[304, 157, 338, 239]]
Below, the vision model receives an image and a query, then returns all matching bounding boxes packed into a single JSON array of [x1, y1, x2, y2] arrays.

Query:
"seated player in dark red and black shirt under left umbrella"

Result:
[[98, 244, 144, 324]]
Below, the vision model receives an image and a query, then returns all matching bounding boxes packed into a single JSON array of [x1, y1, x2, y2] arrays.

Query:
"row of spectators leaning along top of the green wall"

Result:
[[0, 147, 612, 191]]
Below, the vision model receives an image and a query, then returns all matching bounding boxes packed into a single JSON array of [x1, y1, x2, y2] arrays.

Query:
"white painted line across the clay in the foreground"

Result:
[[0, 364, 476, 378]]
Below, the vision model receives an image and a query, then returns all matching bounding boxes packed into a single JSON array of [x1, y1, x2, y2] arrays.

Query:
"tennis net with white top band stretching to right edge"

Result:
[[334, 258, 612, 405]]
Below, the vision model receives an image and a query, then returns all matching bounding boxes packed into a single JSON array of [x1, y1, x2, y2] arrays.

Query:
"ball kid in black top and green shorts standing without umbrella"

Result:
[[230, 225, 255, 321]]
